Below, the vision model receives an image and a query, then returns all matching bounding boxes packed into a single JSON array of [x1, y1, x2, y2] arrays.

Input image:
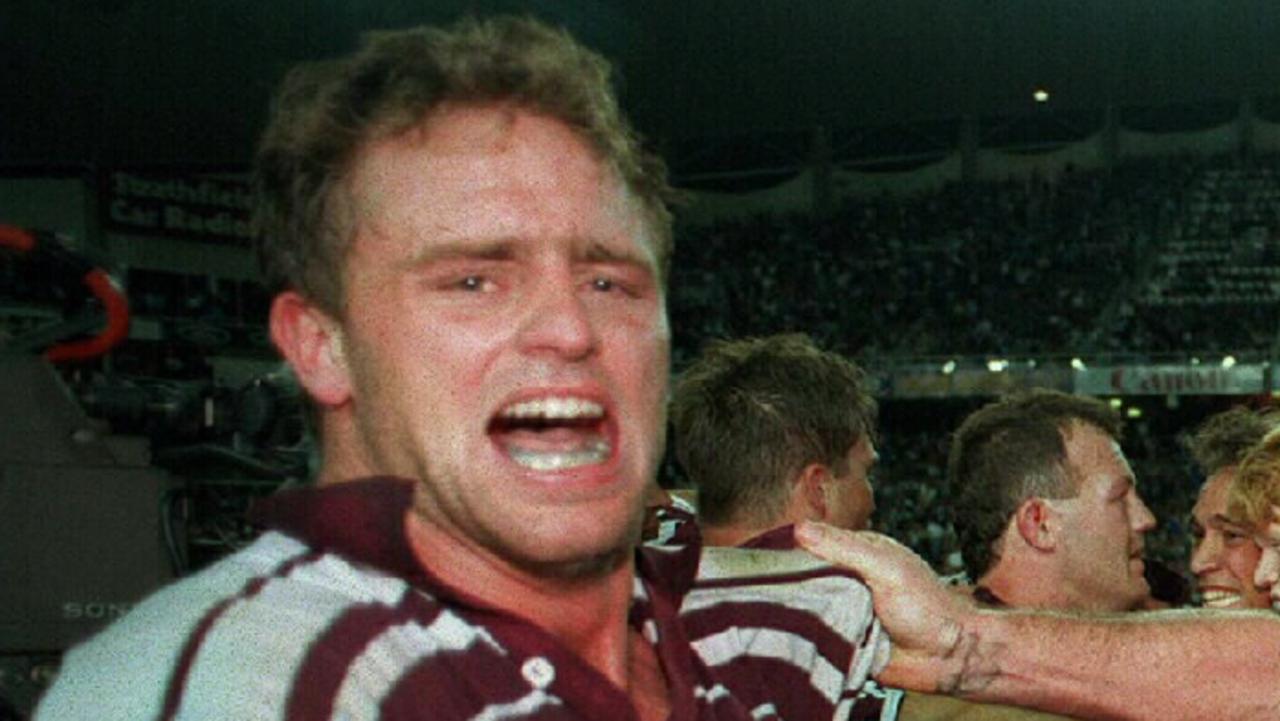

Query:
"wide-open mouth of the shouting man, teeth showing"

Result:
[[488, 396, 613, 473]]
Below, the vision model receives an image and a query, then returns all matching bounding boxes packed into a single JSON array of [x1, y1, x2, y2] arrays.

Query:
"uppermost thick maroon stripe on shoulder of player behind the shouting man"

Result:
[[681, 602, 854, 674]]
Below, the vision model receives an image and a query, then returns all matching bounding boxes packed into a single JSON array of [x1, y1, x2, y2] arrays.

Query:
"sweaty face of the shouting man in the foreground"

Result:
[[338, 106, 669, 574]]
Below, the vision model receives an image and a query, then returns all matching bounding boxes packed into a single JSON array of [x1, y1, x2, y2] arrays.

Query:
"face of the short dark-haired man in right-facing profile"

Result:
[[1056, 424, 1156, 611]]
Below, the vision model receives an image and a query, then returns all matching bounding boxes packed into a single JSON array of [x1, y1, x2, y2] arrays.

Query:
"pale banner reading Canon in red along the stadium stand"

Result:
[[1074, 364, 1267, 396]]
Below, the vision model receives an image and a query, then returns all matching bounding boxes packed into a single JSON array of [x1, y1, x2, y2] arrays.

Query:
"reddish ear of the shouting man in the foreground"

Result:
[[270, 291, 351, 406]]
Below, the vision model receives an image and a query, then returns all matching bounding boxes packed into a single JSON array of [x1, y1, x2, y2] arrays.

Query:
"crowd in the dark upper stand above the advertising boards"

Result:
[[671, 155, 1280, 369]]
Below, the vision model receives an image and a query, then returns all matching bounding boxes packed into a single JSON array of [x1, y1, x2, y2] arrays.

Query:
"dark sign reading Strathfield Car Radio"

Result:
[[101, 170, 252, 245]]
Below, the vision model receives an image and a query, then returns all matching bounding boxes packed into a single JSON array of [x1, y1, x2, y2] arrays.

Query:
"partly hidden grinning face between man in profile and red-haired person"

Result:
[[1192, 466, 1271, 608]]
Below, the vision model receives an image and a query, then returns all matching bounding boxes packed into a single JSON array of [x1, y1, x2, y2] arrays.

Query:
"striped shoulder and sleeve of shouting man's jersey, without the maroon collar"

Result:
[[38, 534, 562, 721]]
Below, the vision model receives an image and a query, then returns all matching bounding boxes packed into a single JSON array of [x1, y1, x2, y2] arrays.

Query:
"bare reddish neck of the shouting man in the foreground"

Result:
[[404, 510, 644, 690]]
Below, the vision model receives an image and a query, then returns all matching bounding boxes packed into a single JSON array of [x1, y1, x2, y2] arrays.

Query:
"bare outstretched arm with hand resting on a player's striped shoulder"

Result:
[[796, 525, 1280, 720]]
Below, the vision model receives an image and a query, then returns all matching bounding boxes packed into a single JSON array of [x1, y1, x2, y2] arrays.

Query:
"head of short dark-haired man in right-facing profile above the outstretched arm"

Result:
[[947, 391, 1156, 611]]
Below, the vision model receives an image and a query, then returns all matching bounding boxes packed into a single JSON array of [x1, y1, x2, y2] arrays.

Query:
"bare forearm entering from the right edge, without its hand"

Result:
[[938, 611, 1280, 720]]
